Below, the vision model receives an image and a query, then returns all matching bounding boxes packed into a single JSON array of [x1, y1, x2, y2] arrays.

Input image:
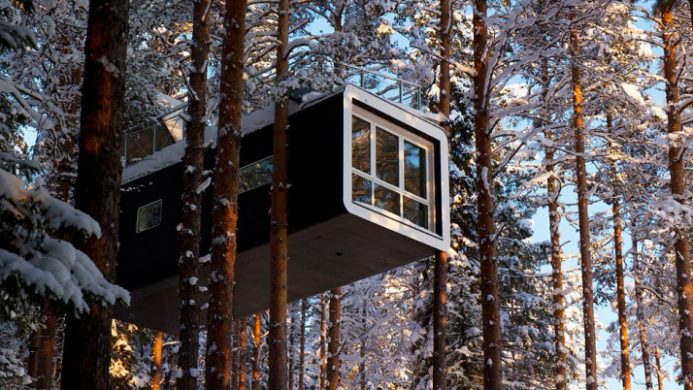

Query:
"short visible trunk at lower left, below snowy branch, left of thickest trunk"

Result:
[[28, 299, 59, 390]]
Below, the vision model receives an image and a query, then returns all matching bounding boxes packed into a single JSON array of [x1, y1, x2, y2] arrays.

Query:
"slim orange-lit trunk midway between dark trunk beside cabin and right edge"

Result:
[[570, 26, 597, 390]]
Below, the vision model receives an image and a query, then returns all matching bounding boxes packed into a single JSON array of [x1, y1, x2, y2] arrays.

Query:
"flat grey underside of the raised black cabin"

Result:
[[116, 214, 432, 334]]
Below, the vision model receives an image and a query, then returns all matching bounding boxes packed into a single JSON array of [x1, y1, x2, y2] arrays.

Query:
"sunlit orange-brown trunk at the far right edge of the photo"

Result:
[[662, 6, 693, 390]]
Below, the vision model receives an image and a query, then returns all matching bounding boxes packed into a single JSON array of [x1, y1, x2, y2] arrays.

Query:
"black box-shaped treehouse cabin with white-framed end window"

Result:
[[117, 86, 449, 332]]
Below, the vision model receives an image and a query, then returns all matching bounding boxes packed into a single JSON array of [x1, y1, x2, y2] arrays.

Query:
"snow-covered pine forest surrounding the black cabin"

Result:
[[0, 0, 693, 390]]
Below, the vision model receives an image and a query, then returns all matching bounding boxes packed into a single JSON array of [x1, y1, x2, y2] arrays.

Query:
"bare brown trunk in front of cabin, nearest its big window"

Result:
[[269, 0, 289, 384]]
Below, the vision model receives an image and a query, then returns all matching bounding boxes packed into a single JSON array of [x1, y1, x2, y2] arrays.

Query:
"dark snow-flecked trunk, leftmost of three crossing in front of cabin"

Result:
[[176, 0, 210, 390]]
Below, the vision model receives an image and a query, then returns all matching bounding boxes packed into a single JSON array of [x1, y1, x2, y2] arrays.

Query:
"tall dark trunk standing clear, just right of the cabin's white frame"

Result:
[[472, 0, 502, 390]]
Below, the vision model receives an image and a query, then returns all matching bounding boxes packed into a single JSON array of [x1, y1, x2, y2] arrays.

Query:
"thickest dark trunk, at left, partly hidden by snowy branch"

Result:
[[61, 0, 129, 390]]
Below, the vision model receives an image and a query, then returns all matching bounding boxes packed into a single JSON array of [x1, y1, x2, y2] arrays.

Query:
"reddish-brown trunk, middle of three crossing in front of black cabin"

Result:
[[205, 0, 246, 389]]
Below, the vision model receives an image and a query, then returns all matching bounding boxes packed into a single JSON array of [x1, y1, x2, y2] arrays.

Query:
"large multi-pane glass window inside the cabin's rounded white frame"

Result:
[[351, 114, 435, 230]]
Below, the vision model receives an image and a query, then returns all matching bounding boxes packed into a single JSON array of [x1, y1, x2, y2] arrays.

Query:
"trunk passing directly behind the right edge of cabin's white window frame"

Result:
[[433, 0, 452, 390]]
